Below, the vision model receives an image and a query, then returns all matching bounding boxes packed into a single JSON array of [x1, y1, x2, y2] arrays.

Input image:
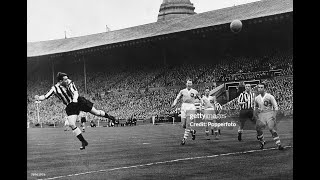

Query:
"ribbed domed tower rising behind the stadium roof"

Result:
[[158, 0, 196, 21]]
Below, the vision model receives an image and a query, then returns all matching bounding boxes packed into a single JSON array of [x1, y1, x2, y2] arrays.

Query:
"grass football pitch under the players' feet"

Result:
[[27, 119, 293, 180]]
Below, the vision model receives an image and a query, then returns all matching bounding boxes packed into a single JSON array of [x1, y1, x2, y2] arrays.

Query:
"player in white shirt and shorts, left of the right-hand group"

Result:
[[171, 80, 200, 145]]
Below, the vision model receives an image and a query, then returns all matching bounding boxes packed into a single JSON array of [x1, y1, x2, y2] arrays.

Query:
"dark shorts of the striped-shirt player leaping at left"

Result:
[[66, 96, 93, 116]]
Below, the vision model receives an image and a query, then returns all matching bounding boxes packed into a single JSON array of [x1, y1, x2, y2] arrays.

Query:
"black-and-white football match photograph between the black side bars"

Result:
[[25, 0, 294, 180]]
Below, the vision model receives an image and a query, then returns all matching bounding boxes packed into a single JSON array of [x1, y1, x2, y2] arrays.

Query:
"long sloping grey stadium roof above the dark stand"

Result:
[[27, 0, 293, 57]]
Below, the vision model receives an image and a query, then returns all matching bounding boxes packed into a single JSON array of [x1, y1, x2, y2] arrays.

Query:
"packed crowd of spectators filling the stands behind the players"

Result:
[[27, 49, 293, 122]]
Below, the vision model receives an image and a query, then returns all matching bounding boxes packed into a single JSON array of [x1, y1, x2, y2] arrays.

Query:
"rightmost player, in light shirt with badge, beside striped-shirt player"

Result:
[[253, 83, 283, 150]]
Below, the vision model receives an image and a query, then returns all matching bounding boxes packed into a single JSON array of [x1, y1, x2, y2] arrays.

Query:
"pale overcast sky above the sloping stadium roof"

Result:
[[27, 0, 257, 42]]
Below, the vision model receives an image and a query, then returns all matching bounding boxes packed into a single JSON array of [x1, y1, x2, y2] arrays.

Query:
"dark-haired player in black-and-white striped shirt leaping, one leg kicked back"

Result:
[[35, 72, 115, 150]]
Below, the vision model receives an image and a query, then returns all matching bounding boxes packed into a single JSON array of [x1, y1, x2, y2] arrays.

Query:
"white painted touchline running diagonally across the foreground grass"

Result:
[[38, 146, 293, 180]]
